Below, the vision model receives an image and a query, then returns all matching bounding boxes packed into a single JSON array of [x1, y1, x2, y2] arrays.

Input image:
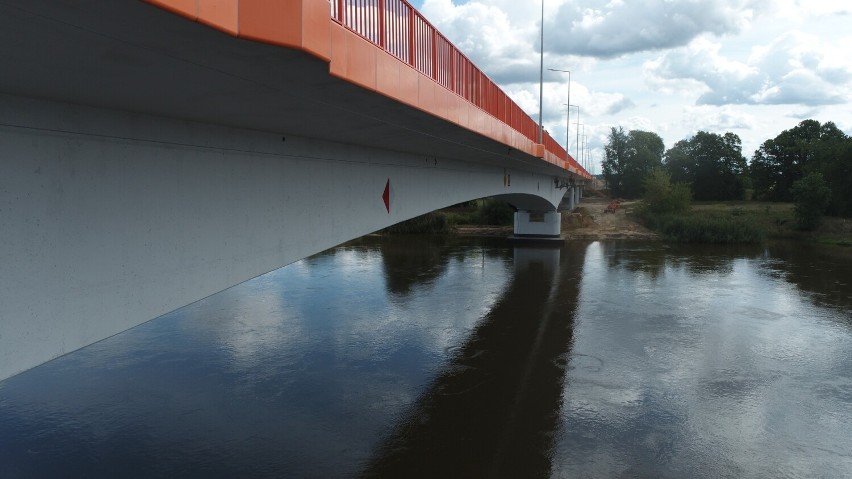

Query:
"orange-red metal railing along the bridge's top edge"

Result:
[[331, 0, 579, 169]]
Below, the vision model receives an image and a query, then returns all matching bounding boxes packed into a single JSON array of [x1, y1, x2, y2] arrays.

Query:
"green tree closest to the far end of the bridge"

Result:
[[601, 127, 665, 198]]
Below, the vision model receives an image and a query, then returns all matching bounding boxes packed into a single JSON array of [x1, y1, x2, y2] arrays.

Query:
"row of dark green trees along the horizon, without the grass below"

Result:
[[602, 120, 852, 216]]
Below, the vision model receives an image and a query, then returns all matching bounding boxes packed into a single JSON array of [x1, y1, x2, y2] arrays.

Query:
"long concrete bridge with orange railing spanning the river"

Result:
[[0, 0, 589, 380]]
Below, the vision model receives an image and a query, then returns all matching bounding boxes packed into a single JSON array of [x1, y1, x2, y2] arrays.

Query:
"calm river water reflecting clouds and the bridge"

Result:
[[0, 237, 852, 479]]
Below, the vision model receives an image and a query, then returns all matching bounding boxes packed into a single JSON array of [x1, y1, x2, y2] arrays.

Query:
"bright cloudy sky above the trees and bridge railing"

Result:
[[411, 0, 852, 173]]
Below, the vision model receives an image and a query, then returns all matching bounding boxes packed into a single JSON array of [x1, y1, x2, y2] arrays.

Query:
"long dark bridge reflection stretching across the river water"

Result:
[[362, 246, 585, 478]]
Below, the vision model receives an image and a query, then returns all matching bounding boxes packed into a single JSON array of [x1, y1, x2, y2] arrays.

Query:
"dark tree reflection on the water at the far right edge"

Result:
[[768, 242, 852, 316]]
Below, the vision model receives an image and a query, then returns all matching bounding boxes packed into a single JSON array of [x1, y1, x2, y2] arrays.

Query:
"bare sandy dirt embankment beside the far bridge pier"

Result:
[[562, 198, 659, 240]]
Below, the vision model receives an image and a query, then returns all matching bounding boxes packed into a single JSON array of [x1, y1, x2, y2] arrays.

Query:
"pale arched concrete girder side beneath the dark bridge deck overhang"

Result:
[[0, 94, 564, 379]]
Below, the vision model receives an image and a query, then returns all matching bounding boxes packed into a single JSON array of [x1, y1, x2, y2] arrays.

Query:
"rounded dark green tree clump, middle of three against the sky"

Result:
[[665, 131, 751, 201]]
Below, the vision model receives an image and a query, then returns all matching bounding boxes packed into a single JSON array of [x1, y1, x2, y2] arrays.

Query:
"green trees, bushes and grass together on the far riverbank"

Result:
[[602, 116, 852, 244]]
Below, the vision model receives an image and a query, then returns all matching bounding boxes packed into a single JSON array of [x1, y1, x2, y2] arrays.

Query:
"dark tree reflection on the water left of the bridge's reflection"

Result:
[[379, 235, 505, 296]]
